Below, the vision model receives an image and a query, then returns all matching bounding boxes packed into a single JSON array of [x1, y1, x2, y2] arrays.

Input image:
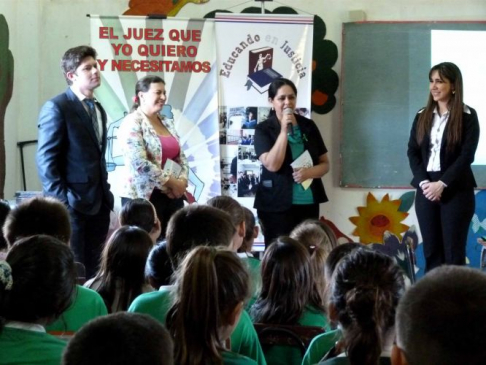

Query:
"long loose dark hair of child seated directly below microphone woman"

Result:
[[251, 236, 318, 325]]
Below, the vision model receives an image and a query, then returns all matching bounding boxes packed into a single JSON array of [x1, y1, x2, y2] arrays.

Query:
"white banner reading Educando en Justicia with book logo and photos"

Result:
[[216, 13, 314, 212]]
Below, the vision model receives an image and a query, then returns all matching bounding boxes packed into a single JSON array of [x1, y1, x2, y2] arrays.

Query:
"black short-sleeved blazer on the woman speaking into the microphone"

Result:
[[254, 115, 328, 212]]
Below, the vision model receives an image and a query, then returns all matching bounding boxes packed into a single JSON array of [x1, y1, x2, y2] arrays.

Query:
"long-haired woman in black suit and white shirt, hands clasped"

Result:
[[408, 62, 479, 272]]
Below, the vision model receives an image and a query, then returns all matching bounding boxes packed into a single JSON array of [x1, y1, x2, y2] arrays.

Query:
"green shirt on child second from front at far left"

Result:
[[46, 285, 108, 336]]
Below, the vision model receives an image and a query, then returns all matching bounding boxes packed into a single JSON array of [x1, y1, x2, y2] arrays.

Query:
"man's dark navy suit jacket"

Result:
[[36, 88, 113, 215]]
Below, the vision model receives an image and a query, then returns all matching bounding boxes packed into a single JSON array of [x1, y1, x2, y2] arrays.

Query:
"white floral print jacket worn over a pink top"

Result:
[[118, 108, 189, 199]]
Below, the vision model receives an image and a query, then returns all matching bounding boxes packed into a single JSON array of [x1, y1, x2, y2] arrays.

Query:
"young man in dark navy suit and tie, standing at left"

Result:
[[37, 46, 113, 278]]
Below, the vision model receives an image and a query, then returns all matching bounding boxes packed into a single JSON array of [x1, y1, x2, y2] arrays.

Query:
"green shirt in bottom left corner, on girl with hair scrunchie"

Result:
[[0, 327, 67, 365]]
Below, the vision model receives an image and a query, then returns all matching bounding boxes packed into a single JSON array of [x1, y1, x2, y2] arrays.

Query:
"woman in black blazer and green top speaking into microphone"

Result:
[[254, 78, 329, 247]]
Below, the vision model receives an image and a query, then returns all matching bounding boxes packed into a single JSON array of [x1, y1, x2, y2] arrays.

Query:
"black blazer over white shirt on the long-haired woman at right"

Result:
[[407, 106, 479, 192]]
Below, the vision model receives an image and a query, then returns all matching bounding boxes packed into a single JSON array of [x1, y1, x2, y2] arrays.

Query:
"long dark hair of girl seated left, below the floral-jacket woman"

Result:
[[84, 226, 154, 313]]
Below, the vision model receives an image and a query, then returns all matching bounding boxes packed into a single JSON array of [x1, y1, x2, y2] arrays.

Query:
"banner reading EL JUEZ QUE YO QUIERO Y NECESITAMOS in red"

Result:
[[91, 15, 221, 202]]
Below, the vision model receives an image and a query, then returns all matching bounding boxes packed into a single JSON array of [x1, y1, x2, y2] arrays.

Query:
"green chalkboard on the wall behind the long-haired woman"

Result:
[[340, 22, 486, 188]]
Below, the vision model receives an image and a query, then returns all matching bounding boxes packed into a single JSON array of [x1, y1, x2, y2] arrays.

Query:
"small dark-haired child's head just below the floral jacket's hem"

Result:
[[119, 198, 157, 233]]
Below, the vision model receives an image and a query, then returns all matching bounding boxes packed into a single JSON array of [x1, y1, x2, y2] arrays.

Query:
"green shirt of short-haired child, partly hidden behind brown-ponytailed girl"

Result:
[[128, 286, 266, 365]]
